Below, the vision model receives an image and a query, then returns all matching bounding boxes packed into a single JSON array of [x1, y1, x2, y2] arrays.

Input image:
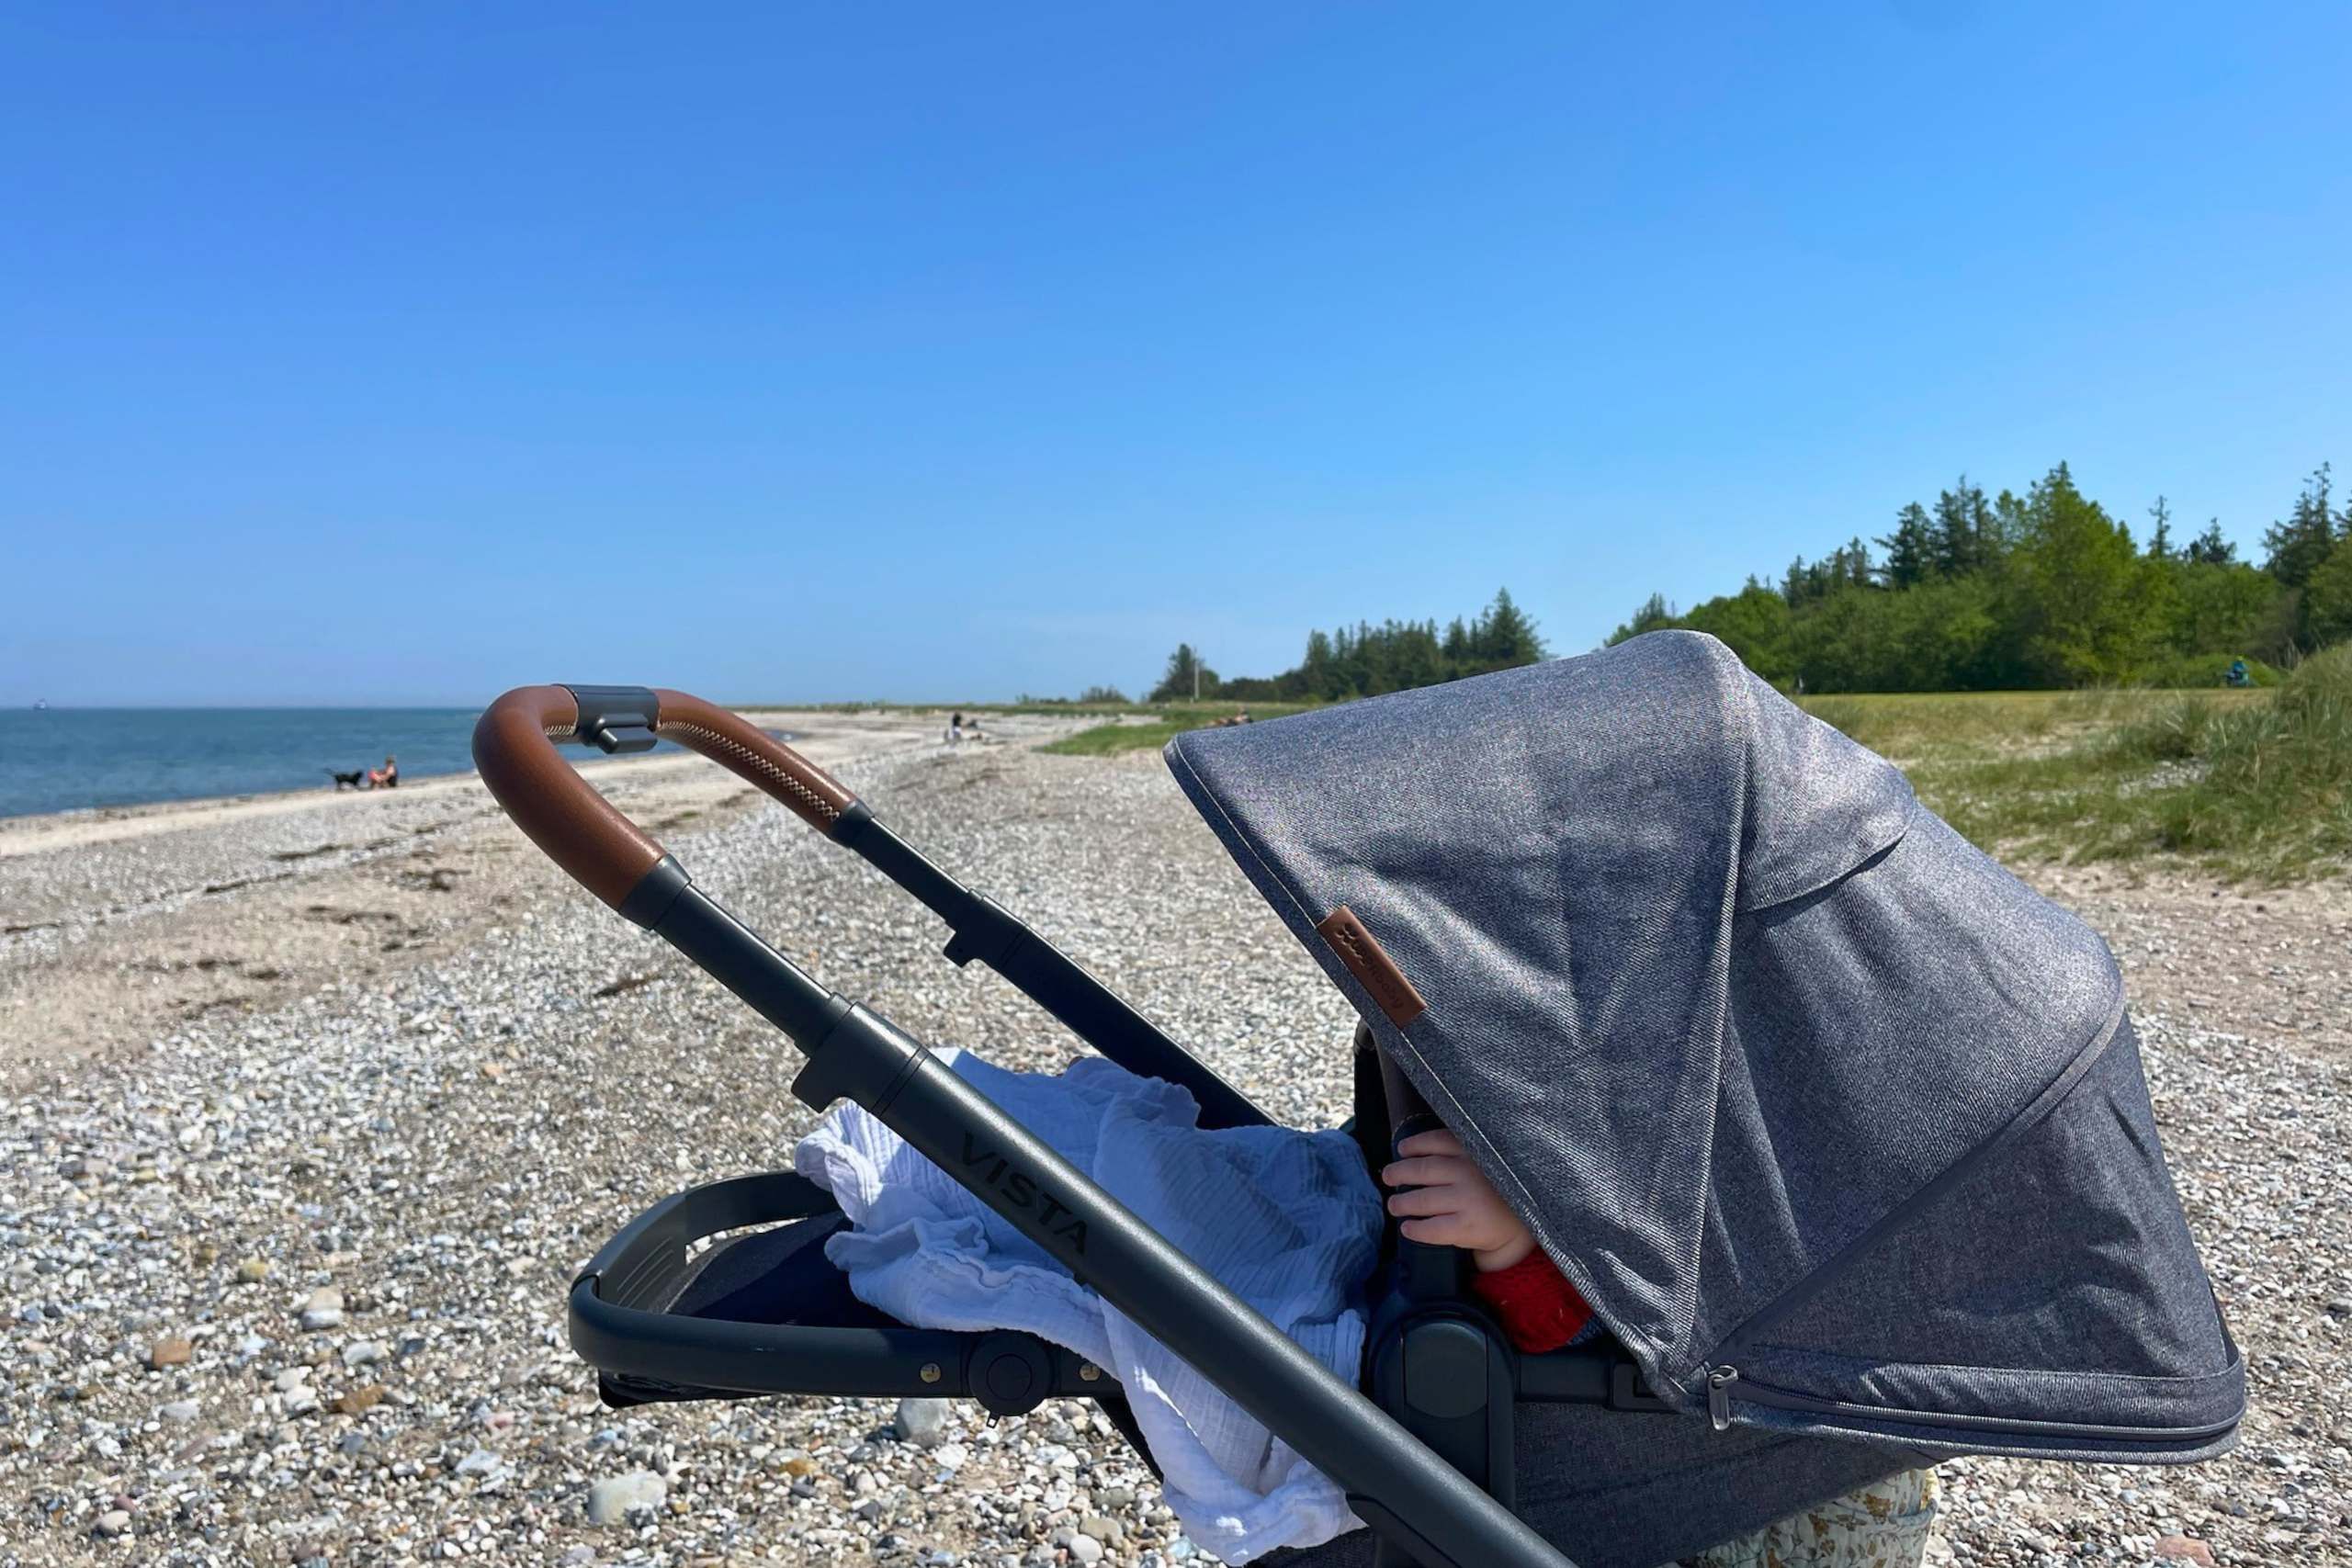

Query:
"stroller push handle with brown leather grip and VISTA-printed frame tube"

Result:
[[473, 686, 1571, 1568]]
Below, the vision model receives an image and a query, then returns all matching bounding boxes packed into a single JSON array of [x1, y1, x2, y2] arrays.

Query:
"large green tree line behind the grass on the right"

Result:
[[1609, 463, 2352, 691]]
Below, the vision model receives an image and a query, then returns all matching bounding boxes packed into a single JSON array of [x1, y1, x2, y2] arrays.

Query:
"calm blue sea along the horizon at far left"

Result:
[[0, 707, 673, 816]]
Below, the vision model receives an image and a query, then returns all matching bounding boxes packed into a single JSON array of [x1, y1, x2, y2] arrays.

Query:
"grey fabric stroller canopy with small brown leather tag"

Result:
[[1169, 632, 2244, 1460]]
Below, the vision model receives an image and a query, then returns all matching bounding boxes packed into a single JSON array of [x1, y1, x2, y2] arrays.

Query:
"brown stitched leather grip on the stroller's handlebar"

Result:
[[473, 686, 856, 909]]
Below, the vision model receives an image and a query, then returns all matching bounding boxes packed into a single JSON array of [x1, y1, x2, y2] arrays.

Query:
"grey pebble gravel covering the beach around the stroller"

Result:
[[0, 748, 2352, 1565]]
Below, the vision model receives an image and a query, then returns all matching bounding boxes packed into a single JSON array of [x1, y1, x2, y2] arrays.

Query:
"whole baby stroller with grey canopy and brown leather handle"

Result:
[[475, 632, 2244, 1568]]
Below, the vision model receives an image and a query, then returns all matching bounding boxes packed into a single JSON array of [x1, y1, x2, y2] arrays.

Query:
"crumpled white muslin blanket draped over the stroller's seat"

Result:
[[793, 1051, 1381, 1563]]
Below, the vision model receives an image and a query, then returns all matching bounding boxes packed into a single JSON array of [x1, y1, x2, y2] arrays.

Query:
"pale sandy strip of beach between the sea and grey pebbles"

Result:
[[0, 710, 1063, 1086]]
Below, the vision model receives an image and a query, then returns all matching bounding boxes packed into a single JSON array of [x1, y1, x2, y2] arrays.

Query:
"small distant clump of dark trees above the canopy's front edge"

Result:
[[1146, 588, 1543, 703]]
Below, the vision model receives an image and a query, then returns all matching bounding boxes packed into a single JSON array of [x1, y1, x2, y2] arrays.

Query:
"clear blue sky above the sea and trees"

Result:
[[0, 0, 2352, 703]]
